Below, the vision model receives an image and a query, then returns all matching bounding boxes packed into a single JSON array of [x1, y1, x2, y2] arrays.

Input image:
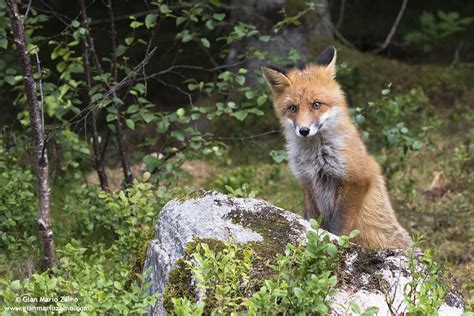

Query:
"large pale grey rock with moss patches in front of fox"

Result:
[[144, 191, 464, 315]]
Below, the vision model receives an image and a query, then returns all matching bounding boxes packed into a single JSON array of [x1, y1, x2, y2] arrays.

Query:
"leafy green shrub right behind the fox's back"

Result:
[[352, 85, 440, 193]]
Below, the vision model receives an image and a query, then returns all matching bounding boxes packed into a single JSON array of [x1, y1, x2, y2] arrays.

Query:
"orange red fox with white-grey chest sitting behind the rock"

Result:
[[262, 46, 412, 249]]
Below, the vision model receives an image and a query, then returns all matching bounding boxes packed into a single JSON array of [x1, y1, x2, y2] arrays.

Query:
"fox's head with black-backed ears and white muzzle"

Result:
[[262, 46, 347, 138]]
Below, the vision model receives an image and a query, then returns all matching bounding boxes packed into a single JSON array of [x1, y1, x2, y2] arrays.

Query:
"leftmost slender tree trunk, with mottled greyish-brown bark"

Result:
[[7, 0, 56, 267]]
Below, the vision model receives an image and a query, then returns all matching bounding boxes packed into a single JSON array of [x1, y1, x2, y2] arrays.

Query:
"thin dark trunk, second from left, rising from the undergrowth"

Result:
[[80, 0, 110, 191]]
